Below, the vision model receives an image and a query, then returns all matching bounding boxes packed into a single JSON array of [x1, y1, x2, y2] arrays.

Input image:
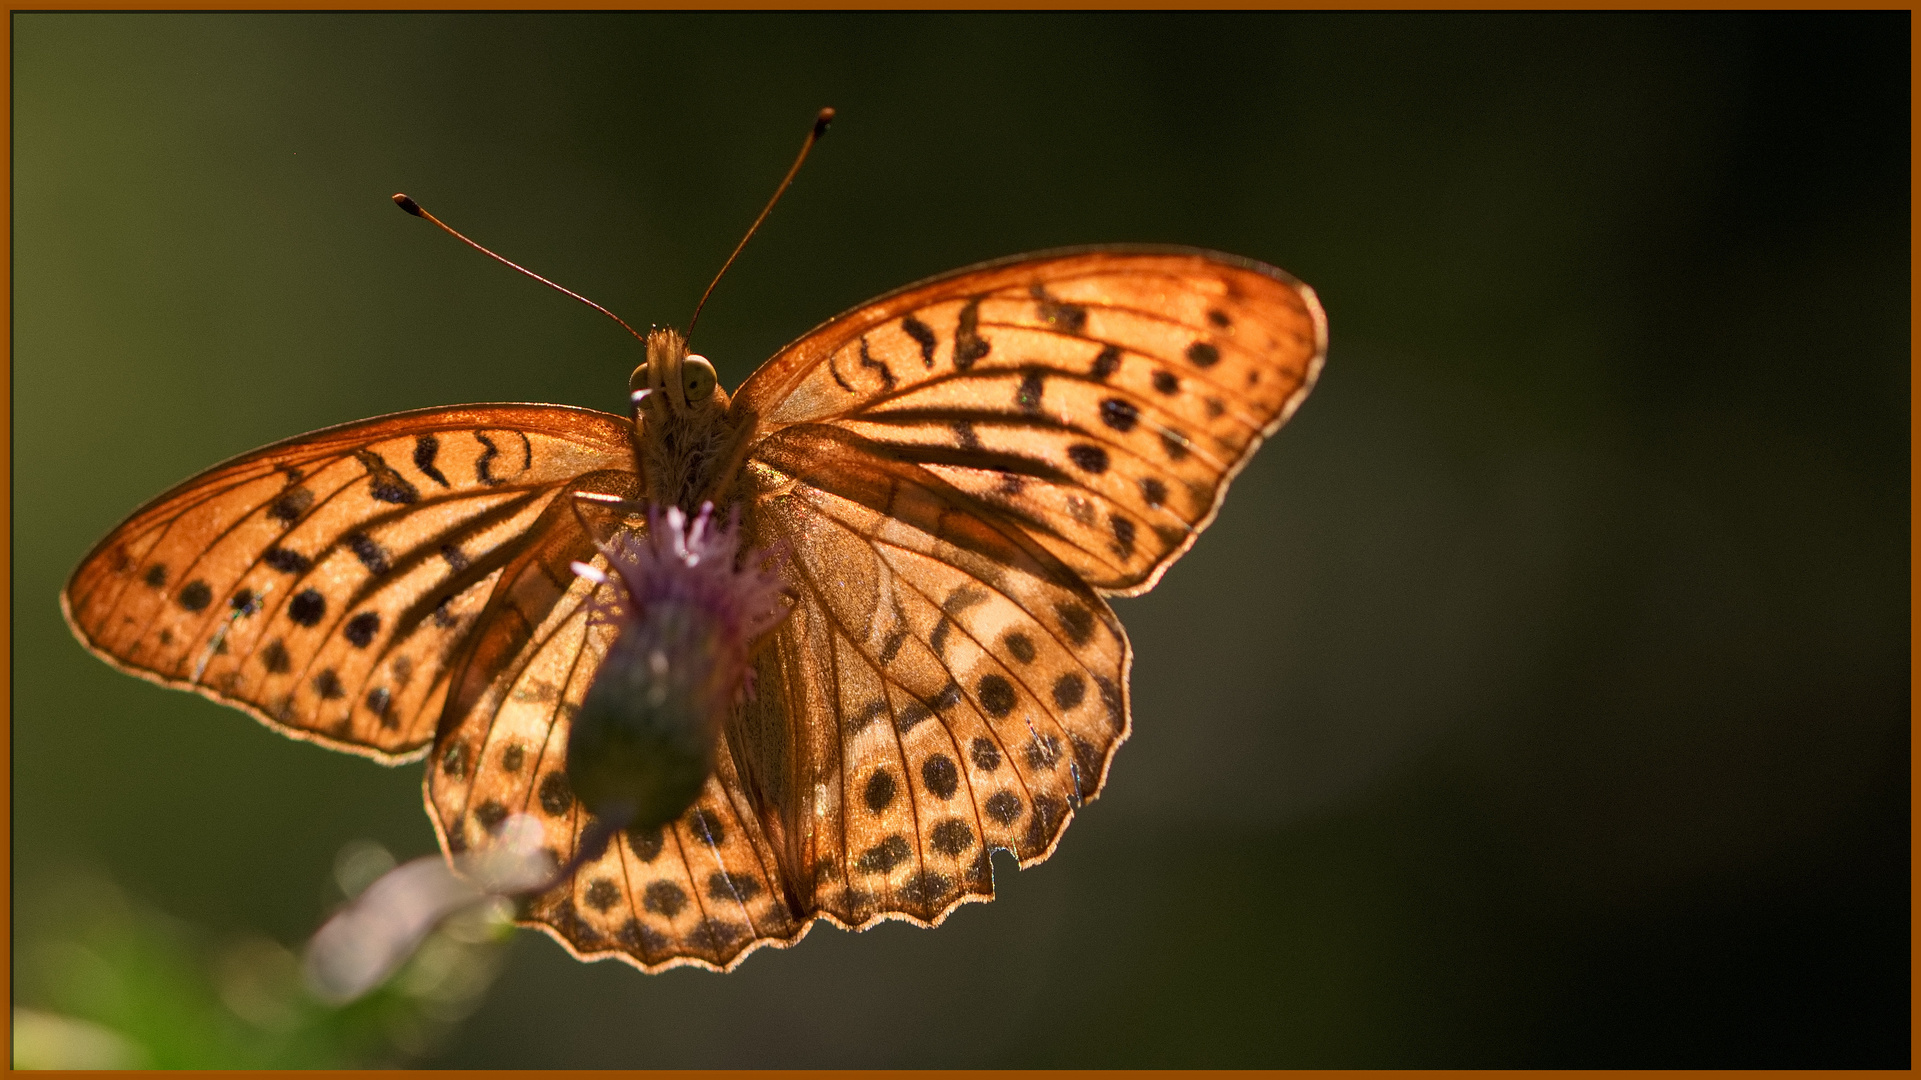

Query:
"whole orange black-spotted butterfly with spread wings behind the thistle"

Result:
[[61, 233, 1327, 970]]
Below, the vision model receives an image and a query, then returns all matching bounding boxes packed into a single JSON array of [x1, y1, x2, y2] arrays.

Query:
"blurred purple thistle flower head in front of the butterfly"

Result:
[[567, 503, 788, 826]]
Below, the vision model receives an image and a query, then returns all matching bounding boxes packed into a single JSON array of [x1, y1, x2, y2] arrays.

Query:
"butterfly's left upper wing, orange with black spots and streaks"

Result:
[[61, 405, 638, 761]]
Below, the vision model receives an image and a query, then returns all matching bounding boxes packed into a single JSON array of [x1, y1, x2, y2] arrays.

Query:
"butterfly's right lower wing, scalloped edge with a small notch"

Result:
[[738, 425, 1128, 926]]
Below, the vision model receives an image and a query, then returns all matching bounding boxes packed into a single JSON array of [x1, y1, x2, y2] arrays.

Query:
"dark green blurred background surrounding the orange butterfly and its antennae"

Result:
[[12, 12, 1909, 1067]]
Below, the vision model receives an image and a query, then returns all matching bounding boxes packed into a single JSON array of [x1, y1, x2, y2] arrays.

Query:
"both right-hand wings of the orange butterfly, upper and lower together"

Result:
[[730, 250, 1327, 926]]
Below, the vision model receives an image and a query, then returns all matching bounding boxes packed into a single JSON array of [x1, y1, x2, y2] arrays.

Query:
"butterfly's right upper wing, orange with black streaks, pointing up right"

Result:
[[738, 250, 1325, 594]]
